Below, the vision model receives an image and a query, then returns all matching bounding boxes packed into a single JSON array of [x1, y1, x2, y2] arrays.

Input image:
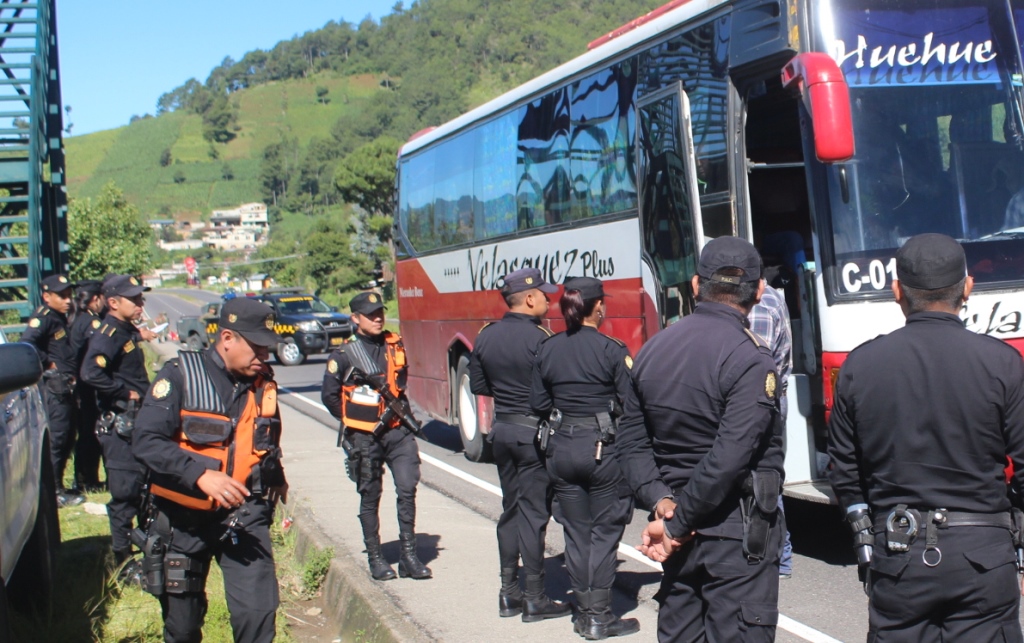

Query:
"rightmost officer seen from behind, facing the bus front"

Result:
[[828, 233, 1024, 641]]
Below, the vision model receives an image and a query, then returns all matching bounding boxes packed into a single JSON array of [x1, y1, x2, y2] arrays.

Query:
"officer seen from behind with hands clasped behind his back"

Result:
[[620, 237, 782, 641]]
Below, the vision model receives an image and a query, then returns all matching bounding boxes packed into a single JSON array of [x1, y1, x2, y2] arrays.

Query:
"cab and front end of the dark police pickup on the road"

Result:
[[256, 288, 352, 367]]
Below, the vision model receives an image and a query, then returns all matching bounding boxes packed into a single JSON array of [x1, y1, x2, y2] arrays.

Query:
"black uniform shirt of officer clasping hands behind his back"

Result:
[[616, 302, 782, 538]]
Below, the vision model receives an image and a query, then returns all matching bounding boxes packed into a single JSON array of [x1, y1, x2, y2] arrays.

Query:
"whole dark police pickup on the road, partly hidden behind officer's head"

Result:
[[178, 288, 352, 367]]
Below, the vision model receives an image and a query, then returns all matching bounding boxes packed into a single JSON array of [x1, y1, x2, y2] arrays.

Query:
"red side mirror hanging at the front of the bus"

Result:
[[782, 51, 854, 163]]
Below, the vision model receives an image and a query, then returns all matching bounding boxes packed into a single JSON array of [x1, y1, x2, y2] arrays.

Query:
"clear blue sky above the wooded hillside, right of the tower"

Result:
[[57, 0, 397, 136]]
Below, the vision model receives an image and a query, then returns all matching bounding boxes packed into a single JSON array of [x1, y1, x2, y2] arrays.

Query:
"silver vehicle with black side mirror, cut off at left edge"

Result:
[[0, 332, 60, 643]]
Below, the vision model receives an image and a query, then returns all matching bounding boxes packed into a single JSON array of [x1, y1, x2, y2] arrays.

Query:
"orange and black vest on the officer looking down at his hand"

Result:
[[150, 350, 281, 511]]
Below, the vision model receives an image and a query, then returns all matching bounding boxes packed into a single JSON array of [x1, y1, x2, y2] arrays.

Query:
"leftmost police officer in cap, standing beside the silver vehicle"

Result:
[[22, 274, 85, 507]]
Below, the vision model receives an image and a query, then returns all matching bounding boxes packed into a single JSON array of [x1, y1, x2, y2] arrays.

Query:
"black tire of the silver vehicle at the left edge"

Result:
[[6, 439, 60, 623]]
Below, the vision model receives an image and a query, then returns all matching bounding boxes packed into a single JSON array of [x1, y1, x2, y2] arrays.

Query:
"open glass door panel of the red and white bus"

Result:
[[637, 82, 703, 336]]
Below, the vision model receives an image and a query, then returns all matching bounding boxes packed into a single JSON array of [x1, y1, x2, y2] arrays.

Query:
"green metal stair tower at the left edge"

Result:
[[0, 0, 69, 332]]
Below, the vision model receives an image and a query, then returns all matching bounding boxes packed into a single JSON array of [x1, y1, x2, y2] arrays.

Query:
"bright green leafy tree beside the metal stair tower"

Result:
[[68, 181, 153, 280]]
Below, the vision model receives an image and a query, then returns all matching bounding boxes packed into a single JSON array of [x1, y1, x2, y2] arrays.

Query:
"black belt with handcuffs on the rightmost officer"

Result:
[[874, 505, 1013, 567]]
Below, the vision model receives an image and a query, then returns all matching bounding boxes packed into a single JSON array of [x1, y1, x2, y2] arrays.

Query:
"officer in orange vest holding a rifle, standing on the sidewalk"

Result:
[[321, 293, 431, 581]]
